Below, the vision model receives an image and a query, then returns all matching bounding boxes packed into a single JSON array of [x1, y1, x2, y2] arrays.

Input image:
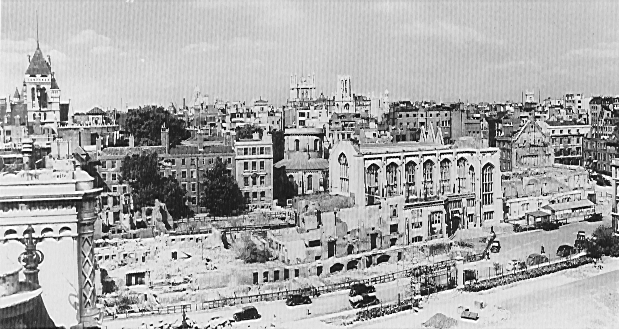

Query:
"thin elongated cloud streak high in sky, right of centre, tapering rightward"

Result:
[[393, 22, 503, 45]]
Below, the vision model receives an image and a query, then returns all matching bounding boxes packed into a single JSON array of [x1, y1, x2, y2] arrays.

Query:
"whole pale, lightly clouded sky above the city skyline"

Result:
[[0, 0, 619, 112]]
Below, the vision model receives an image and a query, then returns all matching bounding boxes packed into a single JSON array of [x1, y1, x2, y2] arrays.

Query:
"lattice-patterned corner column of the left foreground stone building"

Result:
[[77, 196, 98, 324]]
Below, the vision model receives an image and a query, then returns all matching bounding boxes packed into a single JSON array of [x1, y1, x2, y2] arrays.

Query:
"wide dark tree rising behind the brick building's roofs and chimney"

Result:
[[125, 106, 191, 147]]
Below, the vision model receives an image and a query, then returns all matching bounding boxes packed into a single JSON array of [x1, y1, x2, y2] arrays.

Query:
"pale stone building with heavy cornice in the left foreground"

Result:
[[0, 157, 101, 328]]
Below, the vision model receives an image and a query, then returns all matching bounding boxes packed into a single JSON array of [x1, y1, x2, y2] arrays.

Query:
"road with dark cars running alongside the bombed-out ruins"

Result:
[[103, 219, 609, 329]]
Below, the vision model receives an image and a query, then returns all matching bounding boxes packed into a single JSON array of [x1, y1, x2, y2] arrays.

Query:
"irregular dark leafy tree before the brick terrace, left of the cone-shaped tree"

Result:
[[120, 153, 193, 222]]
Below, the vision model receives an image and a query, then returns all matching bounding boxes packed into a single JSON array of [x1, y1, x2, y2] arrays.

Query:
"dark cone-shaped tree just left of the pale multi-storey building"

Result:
[[200, 157, 245, 216]]
